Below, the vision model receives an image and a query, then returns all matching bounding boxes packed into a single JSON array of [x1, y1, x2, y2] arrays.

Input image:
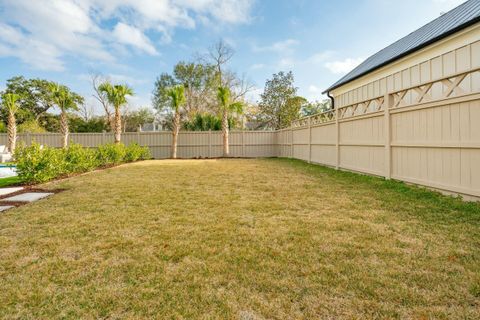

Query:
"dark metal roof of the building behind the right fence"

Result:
[[324, 0, 480, 93]]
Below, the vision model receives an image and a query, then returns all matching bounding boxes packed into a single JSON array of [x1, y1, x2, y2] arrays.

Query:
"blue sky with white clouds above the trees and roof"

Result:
[[0, 0, 463, 113]]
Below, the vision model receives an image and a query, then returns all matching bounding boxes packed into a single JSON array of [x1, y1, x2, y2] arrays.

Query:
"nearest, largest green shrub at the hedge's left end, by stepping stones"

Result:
[[15, 143, 66, 183]]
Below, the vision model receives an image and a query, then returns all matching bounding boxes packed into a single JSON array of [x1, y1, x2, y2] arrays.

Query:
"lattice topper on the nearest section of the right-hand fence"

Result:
[[392, 68, 480, 108]]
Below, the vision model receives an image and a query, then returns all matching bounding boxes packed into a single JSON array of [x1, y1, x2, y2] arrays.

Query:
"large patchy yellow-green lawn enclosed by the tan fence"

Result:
[[0, 159, 480, 319]]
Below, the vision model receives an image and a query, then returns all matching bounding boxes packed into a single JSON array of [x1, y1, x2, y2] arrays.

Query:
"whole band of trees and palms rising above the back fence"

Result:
[[0, 40, 330, 155]]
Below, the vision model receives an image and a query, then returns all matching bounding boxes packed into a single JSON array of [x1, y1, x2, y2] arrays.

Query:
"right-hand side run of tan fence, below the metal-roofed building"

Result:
[[284, 68, 480, 198]]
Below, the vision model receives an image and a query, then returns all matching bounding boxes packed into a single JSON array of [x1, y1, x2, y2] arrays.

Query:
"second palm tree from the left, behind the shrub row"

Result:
[[49, 83, 83, 148]]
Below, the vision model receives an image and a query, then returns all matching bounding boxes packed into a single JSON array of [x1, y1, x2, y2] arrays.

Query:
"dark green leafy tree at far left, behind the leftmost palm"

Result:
[[5, 76, 54, 123]]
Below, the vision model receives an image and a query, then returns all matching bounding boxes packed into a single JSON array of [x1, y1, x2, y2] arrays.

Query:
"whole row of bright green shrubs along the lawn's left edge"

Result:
[[15, 143, 151, 183]]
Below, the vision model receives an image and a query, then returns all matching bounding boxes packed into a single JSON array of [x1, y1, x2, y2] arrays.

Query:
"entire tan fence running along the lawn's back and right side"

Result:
[[0, 68, 480, 199]]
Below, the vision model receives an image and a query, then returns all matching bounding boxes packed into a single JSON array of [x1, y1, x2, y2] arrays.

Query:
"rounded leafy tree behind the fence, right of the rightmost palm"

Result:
[[258, 71, 303, 129]]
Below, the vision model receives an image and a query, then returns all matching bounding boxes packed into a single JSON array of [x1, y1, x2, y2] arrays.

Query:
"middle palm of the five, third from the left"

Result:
[[98, 82, 134, 143]]
